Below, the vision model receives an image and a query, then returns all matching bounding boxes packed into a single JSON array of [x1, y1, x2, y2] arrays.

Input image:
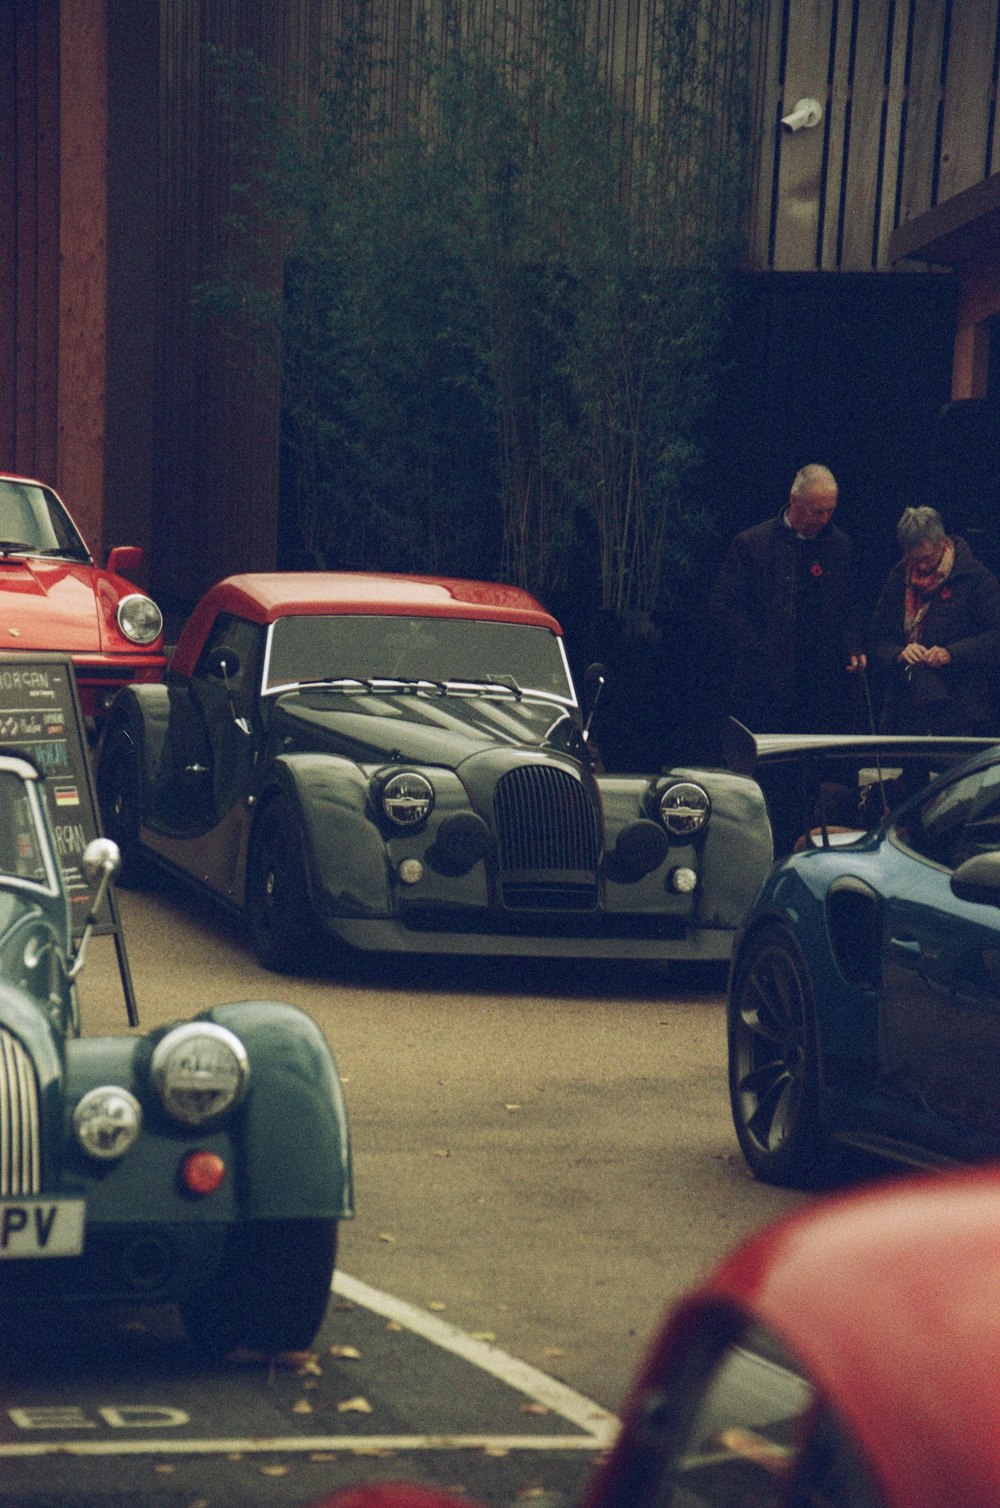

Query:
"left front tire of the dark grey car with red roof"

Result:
[[244, 796, 318, 974]]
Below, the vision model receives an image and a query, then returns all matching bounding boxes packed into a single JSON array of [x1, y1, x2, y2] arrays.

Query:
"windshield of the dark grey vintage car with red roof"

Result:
[[264, 614, 576, 701]]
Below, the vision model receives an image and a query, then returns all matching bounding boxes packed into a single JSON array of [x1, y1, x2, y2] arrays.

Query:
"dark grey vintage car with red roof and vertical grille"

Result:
[[98, 573, 772, 970]]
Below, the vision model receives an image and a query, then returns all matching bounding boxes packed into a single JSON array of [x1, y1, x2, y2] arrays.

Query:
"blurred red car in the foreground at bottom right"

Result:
[[321, 1166, 1000, 1508]]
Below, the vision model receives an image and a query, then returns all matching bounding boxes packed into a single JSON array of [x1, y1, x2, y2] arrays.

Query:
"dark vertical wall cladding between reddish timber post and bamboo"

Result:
[[154, 0, 338, 602]]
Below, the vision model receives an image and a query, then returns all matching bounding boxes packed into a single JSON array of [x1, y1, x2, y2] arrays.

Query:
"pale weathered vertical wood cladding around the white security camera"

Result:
[[751, 0, 1000, 271]]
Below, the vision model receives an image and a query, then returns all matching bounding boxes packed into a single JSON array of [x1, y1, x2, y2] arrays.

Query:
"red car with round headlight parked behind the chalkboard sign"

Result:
[[0, 477, 166, 724]]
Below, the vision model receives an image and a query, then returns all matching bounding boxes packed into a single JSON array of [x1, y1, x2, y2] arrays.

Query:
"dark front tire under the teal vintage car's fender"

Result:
[[181, 1220, 338, 1357]]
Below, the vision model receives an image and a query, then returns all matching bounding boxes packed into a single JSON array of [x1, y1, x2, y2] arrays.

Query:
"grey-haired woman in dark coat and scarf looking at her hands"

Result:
[[872, 508, 1000, 736]]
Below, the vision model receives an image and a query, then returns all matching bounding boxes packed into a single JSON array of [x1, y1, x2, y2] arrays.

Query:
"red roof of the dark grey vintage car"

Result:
[[172, 572, 563, 676]]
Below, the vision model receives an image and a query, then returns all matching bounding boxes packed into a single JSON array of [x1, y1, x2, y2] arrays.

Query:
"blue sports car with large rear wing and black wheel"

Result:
[[729, 734, 1000, 1185]]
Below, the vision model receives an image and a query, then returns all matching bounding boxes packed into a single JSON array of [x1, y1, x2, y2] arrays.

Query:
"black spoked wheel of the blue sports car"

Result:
[[729, 926, 831, 1187]]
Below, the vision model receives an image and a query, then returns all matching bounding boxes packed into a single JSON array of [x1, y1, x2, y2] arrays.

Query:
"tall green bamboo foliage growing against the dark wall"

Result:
[[204, 0, 748, 612]]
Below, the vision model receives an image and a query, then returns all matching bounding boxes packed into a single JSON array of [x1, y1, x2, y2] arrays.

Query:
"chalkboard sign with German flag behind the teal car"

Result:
[[0, 651, 137, 1024]]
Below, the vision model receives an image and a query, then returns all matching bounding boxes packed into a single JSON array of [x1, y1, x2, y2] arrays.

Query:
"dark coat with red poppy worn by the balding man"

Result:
[[710, 510, 860, 733]]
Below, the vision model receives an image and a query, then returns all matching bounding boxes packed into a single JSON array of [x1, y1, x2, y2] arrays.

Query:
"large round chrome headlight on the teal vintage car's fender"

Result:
[[151, 1021, 250, 1126]]
